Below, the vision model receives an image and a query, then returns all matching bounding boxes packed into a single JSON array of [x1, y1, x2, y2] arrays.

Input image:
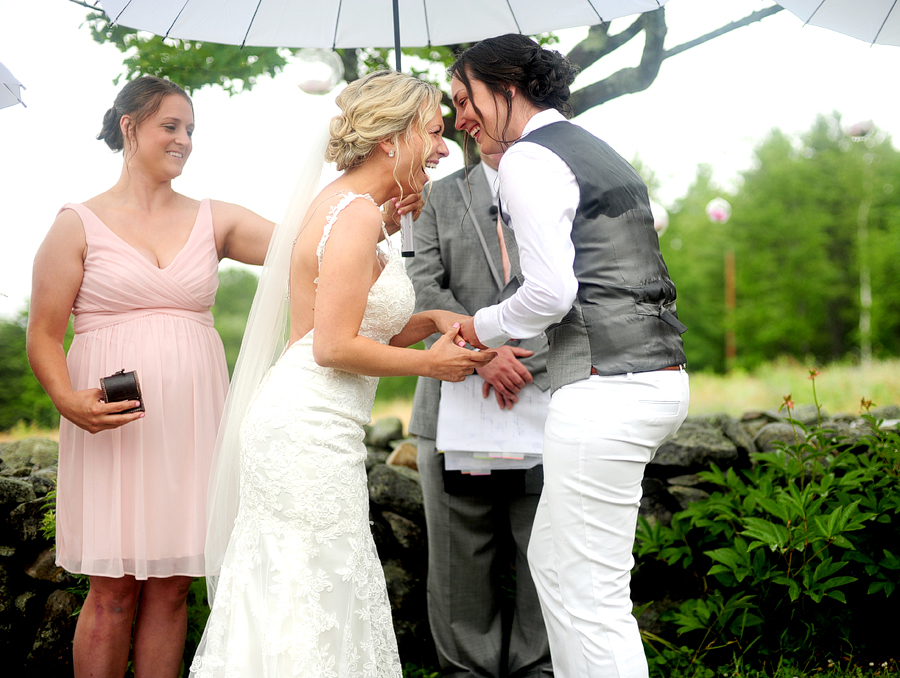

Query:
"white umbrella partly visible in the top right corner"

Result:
[[778, 0, 900, 46]]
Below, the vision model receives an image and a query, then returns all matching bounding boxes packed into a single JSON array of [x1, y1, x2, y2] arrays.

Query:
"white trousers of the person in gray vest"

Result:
[[528, 370, 689, 678]]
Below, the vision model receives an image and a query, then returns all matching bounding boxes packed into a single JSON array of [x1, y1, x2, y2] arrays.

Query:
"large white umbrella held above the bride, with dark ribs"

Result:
[[100, 0, 668, 70]]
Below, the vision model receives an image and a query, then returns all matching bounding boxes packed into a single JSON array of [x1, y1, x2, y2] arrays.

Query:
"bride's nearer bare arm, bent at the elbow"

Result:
[[313, 200, 493, 381]]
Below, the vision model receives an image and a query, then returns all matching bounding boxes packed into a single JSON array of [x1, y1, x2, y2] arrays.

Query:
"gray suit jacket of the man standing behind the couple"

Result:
[[406, 164, 550, 438]]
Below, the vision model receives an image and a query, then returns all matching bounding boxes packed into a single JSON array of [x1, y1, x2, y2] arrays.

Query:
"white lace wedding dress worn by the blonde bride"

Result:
[[191, 194, 415, 678]]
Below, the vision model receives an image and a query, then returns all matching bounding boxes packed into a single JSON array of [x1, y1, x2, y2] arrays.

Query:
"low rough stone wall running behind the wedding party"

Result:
[[0, 406, 900, 678]]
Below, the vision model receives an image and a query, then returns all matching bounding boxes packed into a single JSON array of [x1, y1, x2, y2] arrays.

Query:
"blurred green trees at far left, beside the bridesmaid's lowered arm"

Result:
[[0, 311, 72, 431]]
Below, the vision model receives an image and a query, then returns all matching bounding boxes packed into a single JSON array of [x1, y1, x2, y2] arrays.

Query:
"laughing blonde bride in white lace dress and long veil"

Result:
[[191, 72, 493, 678]]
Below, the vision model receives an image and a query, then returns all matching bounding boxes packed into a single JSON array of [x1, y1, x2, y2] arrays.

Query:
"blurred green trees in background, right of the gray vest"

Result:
[[661, 113, 900, 370]]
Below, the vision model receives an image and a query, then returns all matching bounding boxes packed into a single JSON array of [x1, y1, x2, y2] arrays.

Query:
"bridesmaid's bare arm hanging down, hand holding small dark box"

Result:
[[26, 210, 142, 433]]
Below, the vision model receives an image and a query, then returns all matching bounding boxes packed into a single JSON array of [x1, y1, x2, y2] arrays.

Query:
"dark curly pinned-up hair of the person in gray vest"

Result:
[[448, 33, 578, 146]]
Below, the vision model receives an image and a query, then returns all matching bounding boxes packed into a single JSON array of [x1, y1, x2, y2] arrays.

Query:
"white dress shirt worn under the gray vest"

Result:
[[474, 109, 581, 348]]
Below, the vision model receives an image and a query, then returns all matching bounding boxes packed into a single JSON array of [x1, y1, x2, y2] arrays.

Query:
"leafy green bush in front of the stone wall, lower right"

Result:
[[635, 370, 900, 675]]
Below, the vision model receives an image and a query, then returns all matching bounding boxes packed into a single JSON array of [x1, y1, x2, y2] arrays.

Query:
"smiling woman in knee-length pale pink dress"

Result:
[[28, 77, 273, 677]]
